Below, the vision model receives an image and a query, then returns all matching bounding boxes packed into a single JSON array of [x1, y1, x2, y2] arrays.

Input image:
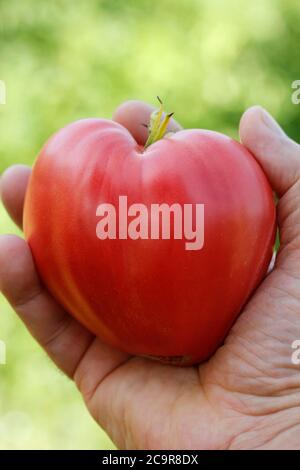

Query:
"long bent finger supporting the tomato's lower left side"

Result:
[[0, 235, 127, 378]]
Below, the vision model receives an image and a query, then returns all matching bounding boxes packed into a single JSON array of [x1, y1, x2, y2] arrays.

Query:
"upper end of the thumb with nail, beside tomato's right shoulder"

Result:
[[240, 106, 300, 195]]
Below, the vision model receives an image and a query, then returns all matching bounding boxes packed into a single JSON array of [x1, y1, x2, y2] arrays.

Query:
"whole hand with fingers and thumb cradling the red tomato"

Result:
[[0, 102, 300, 449]]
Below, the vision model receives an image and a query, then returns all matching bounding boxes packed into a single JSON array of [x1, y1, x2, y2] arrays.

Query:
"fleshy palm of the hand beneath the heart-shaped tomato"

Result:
[[85, 234, 300, 449]]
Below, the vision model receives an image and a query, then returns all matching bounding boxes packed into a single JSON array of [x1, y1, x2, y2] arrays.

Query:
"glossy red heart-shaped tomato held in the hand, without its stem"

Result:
[[24, 119, 276, 365]]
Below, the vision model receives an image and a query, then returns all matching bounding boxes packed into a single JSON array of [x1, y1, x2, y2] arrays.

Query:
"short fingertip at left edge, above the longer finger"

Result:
[[0, 165, 31, 228]]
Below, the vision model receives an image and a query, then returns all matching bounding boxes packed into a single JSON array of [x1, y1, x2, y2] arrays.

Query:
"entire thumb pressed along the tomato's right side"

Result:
[[240, 106, 300, 274]]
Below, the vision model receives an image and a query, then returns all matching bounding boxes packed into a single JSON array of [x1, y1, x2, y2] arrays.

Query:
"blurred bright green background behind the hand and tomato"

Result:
[[0, 0, 300, 449]]
